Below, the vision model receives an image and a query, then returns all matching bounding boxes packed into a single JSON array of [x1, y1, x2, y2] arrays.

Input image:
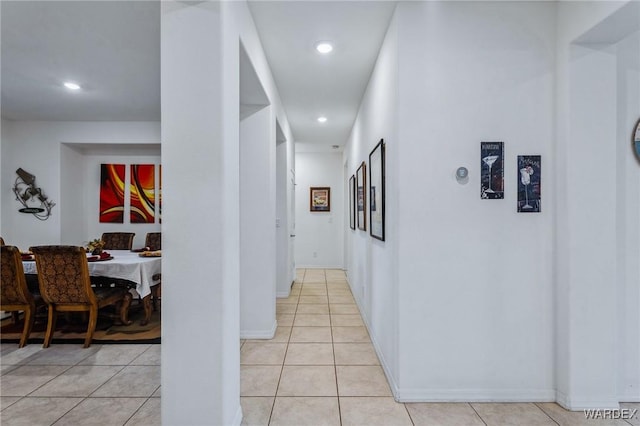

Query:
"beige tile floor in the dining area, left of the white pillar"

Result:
[[0, 344, 160, 426]]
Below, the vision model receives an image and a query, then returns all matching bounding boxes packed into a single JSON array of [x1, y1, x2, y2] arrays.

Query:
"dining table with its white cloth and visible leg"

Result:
[[22, 250, 162, 325]]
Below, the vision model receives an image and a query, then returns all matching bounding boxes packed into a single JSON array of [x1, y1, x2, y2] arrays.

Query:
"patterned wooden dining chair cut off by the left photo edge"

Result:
[[0, 244, 45, 348]]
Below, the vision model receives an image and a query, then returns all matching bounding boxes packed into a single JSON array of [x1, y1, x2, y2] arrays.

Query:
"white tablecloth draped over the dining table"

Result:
[[22, 250, 162, 297]]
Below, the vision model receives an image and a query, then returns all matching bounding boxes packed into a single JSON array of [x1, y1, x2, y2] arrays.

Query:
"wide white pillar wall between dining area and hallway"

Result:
[[161, 1, 242, 425]]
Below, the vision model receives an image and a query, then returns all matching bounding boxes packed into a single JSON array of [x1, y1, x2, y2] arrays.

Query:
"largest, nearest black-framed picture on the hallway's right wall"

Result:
[[369, 139, 385, 241]]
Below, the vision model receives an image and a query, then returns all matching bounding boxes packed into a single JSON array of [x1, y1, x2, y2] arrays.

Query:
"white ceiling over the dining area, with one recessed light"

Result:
[[0, 1, 160, 121]]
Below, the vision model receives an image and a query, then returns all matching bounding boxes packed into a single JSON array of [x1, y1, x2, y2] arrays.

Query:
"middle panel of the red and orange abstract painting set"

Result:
[[129, 164, 156, 223]]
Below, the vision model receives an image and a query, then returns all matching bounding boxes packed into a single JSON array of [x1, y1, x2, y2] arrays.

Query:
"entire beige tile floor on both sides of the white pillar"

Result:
[[0, 269, 640, 426]]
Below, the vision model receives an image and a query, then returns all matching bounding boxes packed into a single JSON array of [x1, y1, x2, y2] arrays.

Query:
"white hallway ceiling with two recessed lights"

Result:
[[249, 1, 395, 146]]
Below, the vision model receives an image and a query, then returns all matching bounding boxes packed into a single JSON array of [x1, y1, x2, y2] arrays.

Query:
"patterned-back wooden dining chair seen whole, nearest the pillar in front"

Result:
[[31, 246, 132, 348]]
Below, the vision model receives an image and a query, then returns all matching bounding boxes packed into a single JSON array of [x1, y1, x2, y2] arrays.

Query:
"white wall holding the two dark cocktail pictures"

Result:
[[397, 2, 555, 401]]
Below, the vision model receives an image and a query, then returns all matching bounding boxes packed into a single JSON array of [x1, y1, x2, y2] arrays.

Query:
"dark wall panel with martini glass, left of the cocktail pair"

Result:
[[480, 142, 504, 200]]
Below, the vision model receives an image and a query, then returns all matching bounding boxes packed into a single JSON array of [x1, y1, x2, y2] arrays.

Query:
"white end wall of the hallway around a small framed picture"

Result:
[[295, 152, 348, 269]]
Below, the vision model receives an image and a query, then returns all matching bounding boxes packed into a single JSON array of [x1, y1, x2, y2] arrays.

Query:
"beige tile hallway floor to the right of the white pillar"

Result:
[[241, 269, 640, 426]]
